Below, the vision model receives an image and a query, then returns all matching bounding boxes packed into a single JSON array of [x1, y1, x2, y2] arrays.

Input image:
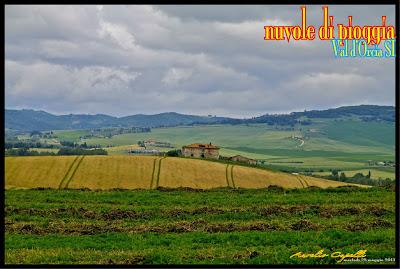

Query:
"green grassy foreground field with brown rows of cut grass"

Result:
[[5, 188, 395, 264]]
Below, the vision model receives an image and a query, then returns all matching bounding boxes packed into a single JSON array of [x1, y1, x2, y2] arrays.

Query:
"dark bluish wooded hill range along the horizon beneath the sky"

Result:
[[5, 105, 395, 131]]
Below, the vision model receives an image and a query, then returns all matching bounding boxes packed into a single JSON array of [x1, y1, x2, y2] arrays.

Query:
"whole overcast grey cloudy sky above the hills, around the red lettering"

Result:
[[5, 5, 395, 117]]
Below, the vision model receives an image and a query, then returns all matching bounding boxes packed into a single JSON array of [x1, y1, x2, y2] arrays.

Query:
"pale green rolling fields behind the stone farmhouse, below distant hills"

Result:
[[51, 119, 395, 178]]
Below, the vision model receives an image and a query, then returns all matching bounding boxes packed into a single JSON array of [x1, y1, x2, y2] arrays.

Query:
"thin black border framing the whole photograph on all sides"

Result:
[[0, 0, 400, 268]]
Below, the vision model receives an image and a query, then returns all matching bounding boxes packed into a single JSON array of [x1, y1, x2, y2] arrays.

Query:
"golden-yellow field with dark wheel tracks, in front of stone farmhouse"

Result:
[[5, 155, 360, 190]]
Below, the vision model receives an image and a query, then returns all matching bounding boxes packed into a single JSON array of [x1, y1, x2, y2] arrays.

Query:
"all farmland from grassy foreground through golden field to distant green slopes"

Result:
[[4, 105, 397, 266]]
